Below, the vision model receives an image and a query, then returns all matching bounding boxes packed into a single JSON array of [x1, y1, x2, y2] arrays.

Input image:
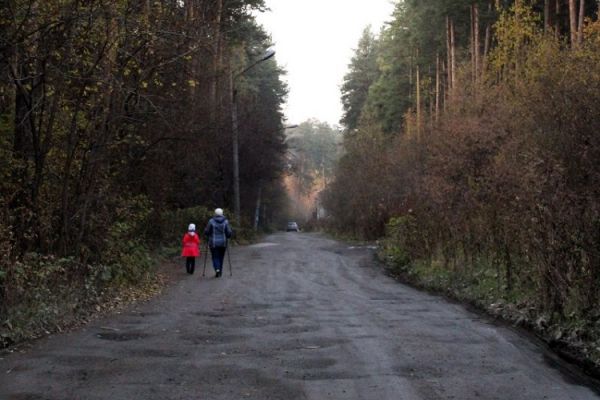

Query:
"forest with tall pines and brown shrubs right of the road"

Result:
[[324, 0, 600, 365]]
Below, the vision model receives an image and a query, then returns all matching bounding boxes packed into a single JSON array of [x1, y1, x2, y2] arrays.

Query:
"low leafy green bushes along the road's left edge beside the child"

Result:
[[0, 198, 156, 347]]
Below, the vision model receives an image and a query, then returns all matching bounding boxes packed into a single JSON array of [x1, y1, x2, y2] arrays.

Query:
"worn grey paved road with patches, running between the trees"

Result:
[[0, 233, 600, 400]]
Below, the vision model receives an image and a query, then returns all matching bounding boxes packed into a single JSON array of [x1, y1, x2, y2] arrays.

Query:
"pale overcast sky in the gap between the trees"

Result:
[[258, 0, 394, 125]]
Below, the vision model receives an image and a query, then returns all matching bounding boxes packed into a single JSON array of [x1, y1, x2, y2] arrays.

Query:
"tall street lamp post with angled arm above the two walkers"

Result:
[[229, 48, 275, 224]]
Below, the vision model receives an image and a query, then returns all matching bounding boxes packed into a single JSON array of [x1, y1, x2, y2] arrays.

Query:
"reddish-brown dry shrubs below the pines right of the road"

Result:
[[326, 27, 600, 321]]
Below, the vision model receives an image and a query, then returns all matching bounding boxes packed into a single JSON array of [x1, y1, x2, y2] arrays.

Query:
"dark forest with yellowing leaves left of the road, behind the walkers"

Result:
[[0, 0, 287, 347]]
